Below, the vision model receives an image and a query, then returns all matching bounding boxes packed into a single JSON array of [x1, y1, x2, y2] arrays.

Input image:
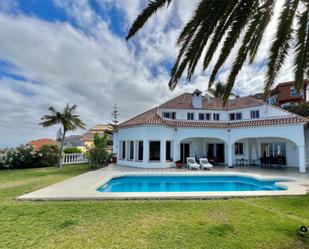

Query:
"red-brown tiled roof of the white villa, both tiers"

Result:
[[118, 93, 308, 128]]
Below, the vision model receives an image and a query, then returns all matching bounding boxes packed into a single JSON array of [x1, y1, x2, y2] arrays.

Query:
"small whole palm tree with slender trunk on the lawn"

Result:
[[40, 104, 85, 168]]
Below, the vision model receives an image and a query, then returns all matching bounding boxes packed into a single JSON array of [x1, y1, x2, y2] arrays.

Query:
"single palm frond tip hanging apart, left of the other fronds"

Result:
[[126, 0, 172, 40]]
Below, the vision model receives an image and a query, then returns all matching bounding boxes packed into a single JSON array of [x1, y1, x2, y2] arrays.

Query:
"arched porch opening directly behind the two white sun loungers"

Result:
[[178, 137, 227, 164]]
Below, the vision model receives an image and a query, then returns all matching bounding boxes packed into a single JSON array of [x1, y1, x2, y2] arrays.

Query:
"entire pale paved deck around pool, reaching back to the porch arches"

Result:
[[17, 164, 309, 201]]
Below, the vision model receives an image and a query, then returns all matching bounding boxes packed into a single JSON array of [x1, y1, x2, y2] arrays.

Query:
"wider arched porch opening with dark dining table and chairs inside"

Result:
[[232, 137, 299, 168]]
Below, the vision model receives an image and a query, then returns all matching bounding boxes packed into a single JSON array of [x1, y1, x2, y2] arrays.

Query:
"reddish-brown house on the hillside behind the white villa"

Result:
[[253, 80, 307, 108]]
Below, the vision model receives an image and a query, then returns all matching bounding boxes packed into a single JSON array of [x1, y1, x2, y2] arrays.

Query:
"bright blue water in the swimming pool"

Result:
[[98, 176, 286, 192]]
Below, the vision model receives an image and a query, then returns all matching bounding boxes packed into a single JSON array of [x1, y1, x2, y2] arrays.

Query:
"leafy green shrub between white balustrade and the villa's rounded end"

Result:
[[86, 134, 111, 168]]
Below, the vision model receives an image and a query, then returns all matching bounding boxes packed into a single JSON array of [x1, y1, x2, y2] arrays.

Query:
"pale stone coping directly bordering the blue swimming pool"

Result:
[[17, 170, 307, 201]]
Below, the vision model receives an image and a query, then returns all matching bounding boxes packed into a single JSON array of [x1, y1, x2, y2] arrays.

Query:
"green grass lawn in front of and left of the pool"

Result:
[[0, 165, 309, 249]]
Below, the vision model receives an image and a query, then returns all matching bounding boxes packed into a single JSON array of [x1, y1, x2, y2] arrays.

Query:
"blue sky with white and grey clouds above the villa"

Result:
[[0, 0, 292, 147]]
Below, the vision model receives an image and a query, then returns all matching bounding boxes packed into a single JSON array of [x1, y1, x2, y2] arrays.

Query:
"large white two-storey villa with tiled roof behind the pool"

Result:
[[113, 90, 309, 172]]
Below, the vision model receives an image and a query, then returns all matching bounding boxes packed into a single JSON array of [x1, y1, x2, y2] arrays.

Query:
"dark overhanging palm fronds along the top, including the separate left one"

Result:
[[126, 0, 309, 101]]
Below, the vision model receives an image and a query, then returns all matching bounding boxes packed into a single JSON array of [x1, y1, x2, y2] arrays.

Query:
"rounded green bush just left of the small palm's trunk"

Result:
[[37, 144, 60, 167]]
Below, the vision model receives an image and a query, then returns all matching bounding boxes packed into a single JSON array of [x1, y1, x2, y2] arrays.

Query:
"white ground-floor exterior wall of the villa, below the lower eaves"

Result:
[[114, 122, 309, 171]]
